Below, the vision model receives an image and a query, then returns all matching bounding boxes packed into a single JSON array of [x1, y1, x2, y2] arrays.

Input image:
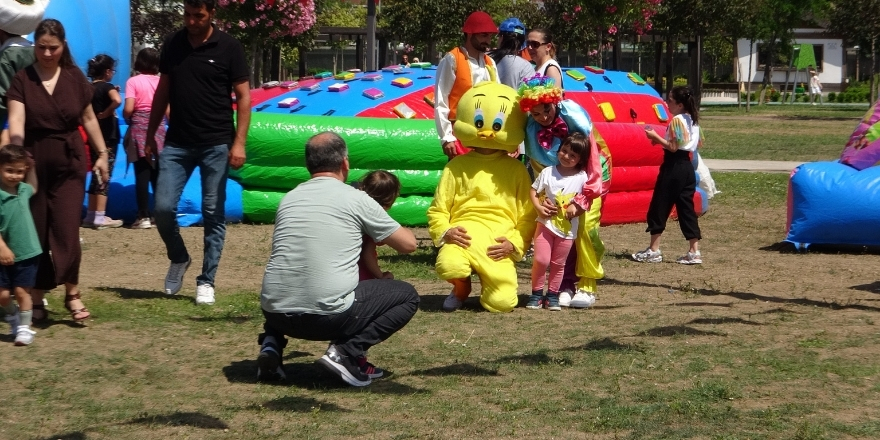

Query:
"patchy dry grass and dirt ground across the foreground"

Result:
[[0, 109, 880, 440]]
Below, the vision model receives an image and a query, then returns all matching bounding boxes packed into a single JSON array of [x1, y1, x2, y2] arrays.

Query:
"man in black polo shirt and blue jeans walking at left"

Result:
[[144, 0, 251, 305]]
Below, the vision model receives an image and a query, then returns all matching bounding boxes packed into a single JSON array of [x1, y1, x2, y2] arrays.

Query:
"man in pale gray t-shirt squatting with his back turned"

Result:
[[257, 132, 419, 386]]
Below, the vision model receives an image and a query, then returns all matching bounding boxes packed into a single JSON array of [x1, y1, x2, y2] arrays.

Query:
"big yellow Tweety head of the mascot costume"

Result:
[[452, 81, 526, 153]]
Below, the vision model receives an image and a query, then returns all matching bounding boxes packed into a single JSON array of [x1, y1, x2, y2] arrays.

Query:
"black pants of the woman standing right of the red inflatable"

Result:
[[646, 151, 702, 240]]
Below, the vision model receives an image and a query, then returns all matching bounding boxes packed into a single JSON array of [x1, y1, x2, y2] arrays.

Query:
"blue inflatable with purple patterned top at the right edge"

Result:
[[785, 101, 880, 249]]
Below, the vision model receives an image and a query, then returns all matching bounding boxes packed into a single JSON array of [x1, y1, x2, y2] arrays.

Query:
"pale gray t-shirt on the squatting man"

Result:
[[260, 177, 400, 315]]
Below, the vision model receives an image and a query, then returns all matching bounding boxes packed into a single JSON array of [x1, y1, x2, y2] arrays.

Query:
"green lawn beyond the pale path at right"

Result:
[[700, 105, 868, 162]]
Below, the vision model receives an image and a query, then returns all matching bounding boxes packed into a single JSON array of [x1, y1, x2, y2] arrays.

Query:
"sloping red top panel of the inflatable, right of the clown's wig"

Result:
[[565, 90, 669, 126]]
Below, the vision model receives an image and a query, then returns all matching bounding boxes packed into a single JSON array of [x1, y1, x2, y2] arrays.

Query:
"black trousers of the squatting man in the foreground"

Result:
[[259, 280, 419, 357]]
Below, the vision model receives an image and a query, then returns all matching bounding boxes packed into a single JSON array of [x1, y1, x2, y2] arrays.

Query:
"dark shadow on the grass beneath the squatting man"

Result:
[[223, 360, 421, 394]]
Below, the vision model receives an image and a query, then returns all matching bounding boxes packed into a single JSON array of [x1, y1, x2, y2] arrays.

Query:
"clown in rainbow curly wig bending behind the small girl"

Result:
[[519, 75, 611, 308]]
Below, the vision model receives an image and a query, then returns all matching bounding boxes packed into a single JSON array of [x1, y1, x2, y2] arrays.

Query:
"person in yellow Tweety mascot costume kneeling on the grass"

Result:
[[428, 81, 536, 312]]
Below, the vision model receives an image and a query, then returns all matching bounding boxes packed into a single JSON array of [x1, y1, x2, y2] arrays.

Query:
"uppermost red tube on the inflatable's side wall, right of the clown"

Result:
[[593, 120, 666, 167]]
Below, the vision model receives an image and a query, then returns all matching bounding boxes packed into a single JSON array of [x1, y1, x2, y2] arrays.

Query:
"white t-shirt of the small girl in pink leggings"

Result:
[[532, 166, 587, 240]]
